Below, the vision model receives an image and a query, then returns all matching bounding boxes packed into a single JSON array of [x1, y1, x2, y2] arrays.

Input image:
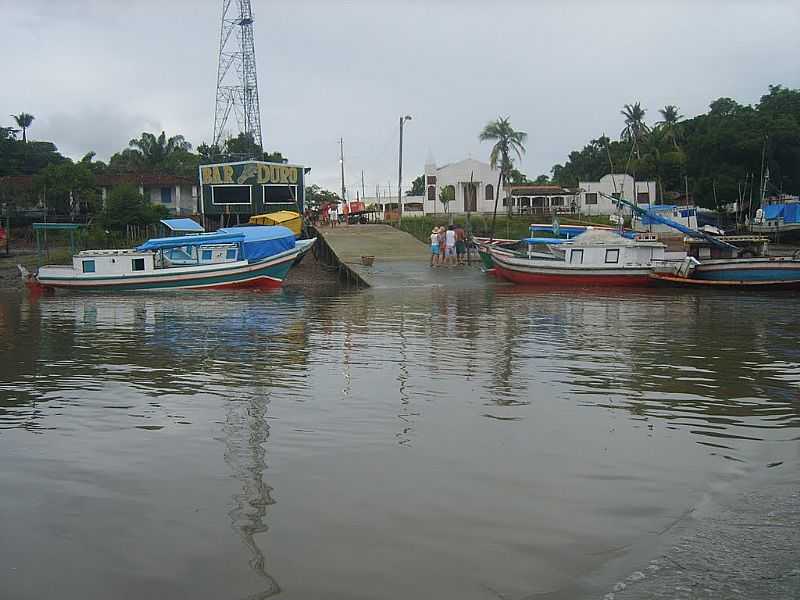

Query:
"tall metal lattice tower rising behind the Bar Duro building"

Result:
[[214, 0, 263, 148]]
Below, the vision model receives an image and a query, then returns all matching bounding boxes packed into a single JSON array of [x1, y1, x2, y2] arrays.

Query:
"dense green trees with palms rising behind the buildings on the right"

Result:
[[551, 85, 800, 209]]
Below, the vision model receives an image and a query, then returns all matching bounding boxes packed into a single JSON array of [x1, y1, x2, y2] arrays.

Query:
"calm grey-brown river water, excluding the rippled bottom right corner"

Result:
[[0, 282, 800, 600]]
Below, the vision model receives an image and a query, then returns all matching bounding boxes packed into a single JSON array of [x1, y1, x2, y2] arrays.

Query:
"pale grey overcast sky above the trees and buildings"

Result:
[[0, 0, 800, 194]]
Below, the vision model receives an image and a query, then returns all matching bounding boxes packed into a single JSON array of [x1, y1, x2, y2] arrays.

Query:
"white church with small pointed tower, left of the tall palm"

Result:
[[423, 158, 500, 215]]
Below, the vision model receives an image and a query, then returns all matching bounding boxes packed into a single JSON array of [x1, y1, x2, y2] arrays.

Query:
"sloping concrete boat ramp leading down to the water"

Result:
[[316, 224, 484, 288]]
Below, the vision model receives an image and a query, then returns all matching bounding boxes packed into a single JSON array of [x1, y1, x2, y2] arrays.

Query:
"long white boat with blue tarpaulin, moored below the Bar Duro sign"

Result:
[[21, 226, 316, 291]]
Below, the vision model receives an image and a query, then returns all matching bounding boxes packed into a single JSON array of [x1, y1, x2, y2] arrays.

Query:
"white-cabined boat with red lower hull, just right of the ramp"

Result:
[[489, 230, 665, 286]]
